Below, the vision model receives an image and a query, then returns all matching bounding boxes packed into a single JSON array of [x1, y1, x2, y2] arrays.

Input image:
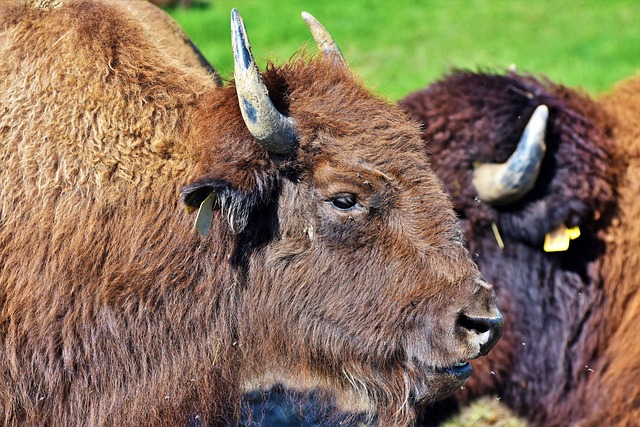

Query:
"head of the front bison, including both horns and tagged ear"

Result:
[[183, 10, 502, 425]]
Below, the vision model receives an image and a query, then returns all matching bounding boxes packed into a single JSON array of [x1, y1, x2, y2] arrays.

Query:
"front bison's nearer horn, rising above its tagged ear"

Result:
[[231, 8, 298, 155]]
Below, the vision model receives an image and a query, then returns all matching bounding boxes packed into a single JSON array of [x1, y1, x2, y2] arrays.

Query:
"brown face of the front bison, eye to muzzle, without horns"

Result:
[[231, 103, 502, 423]]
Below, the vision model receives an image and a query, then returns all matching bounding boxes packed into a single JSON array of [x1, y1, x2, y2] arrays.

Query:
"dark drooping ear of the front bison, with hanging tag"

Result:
[[181, 179, 262, 236]]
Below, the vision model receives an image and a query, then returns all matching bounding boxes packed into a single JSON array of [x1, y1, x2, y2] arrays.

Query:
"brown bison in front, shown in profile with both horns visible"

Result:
[[0, 0, 502, 426]]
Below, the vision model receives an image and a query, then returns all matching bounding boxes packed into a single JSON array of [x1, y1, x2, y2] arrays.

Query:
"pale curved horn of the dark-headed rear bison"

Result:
[[472, 105, 549, 205]]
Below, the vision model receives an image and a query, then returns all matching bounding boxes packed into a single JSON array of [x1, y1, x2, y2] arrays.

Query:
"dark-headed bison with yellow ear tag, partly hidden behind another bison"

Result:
[[400, 72, 640, 426]]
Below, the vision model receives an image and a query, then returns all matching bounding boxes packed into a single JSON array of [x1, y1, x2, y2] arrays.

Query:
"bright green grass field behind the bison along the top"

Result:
[[170, 0, 640, 99]]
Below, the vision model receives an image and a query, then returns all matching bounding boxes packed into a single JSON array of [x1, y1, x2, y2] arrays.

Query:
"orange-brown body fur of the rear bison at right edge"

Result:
[[585, 75, 640, 426]]
